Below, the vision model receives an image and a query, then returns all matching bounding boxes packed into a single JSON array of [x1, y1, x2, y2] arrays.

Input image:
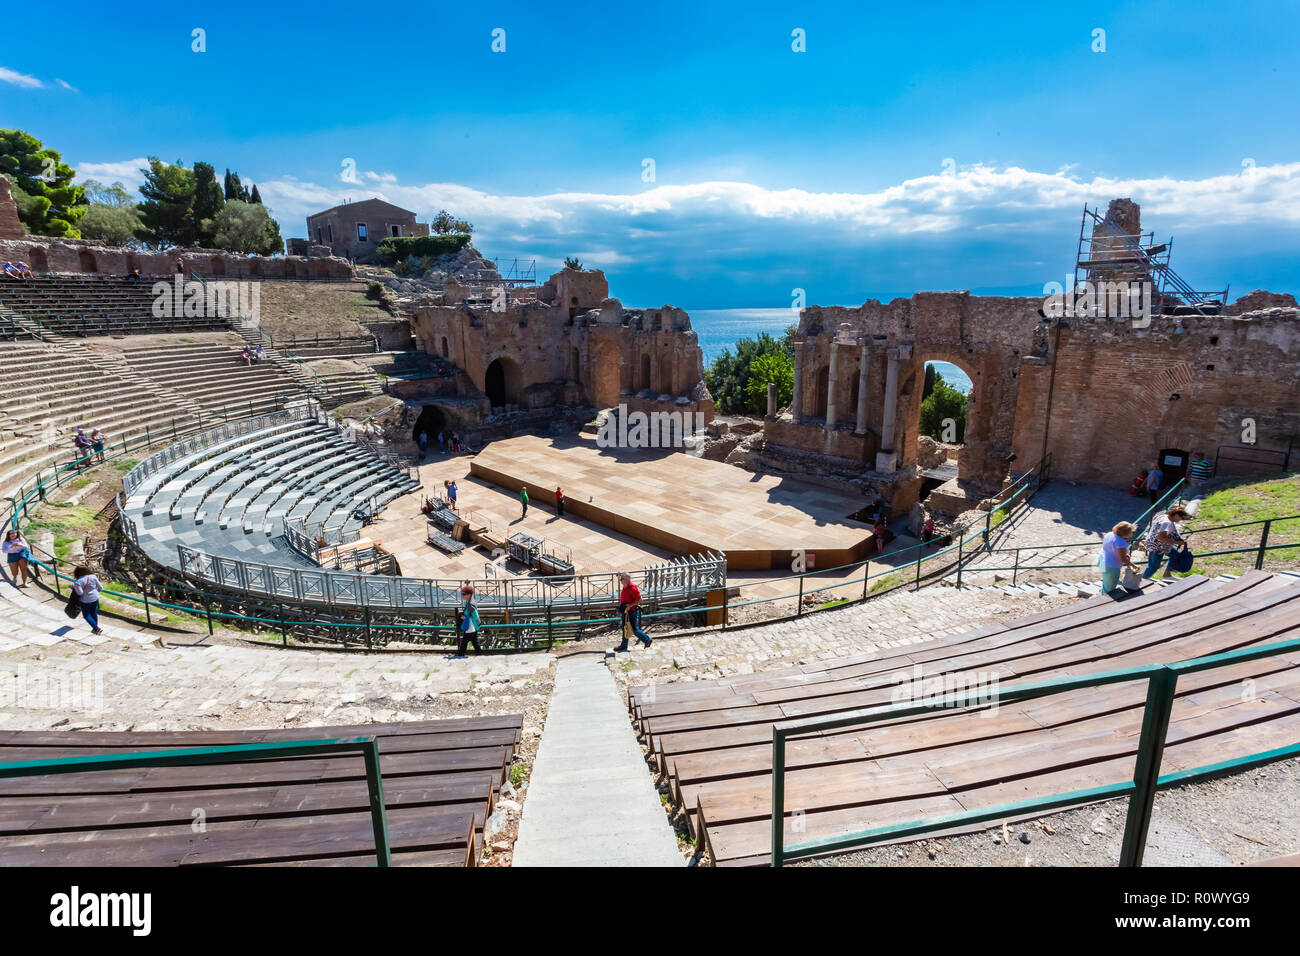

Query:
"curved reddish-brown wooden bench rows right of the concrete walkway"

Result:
[[628, 571, 1300, 865]]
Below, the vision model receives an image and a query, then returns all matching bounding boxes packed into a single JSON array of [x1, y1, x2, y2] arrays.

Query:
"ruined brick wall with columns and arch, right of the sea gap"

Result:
[[764, 291, 1300, 489]]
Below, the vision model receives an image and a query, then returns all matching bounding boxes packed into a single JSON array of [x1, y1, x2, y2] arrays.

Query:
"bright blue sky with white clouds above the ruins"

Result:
[[0, 3, 1300, 308]]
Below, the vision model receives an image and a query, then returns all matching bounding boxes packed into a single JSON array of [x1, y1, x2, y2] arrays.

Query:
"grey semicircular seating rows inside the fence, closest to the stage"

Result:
[[122, 418, 420, 568]]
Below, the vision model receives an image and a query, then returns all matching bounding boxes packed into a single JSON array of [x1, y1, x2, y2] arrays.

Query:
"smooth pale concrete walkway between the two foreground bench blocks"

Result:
[[514, 656, 685, 866]]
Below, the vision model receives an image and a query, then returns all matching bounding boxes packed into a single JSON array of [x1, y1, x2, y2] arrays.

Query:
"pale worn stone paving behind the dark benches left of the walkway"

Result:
[[0, 583, 555, 736]]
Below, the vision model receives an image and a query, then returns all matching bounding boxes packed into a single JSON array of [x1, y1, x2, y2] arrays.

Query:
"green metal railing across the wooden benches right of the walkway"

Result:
[[772, 639, 1300, 866]]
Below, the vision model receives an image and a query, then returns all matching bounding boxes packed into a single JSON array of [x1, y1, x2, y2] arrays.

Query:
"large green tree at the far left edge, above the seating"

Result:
[[0, 129, 86, 239]]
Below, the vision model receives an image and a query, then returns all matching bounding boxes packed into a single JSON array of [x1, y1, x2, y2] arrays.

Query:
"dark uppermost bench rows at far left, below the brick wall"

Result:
[[0, 276, 230, 336]]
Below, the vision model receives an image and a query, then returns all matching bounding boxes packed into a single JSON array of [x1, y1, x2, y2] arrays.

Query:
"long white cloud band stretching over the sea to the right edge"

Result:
[[250, 163, 1300, 237]]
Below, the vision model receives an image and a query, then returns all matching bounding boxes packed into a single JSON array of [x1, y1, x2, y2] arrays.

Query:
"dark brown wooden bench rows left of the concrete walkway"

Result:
[[0, 715, 523, 866]]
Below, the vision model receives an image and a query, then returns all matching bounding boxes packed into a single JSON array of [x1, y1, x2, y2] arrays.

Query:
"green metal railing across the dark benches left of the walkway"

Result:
[[0, 736, 393, 866]]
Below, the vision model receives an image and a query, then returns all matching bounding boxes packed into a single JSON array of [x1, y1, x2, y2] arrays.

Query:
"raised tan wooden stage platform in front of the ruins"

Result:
[[469, 436, 872, 571]]
